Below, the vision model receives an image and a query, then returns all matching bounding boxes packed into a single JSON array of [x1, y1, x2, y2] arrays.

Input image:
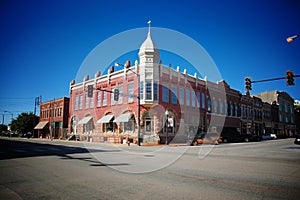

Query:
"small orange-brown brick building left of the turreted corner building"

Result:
[[34, 97, 69, 139]]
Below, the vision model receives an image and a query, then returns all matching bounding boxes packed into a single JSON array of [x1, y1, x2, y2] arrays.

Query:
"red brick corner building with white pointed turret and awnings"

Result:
[[69, 28, 232, 144]]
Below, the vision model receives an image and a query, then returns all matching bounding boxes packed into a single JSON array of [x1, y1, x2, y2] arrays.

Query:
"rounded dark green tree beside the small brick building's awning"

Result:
[[11, 112, 39, 133]]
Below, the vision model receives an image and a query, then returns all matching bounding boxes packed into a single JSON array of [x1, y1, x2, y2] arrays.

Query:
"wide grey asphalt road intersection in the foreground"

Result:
[[0, 138, 300, 200]]
